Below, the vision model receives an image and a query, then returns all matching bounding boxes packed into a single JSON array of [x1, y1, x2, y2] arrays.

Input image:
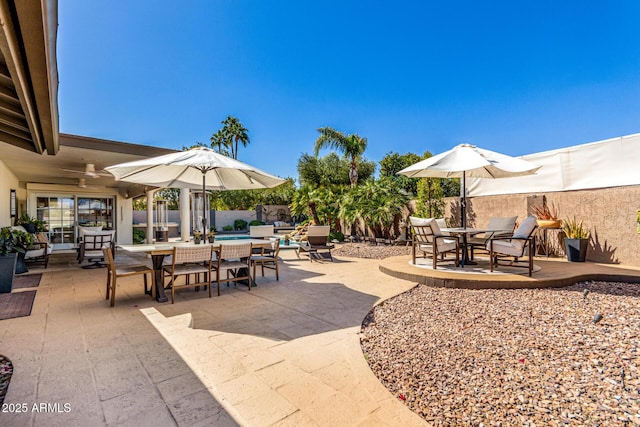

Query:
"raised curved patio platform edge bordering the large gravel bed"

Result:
[[379, 256, 640, 289]]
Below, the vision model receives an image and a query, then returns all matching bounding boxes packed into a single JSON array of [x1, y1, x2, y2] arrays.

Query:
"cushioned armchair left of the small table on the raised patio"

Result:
[[411, 218, 460, 270]]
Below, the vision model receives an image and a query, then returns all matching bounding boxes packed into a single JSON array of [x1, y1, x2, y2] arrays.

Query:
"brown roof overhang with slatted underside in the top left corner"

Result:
[[0, 0, 60, 155]]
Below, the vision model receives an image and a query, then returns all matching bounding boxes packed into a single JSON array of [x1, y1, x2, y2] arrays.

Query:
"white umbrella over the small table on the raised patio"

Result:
[[398, 144, 540, 227]]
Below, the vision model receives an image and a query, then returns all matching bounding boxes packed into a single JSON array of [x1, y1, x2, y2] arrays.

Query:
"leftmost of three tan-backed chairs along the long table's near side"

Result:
[[162, 245, 213, 304]]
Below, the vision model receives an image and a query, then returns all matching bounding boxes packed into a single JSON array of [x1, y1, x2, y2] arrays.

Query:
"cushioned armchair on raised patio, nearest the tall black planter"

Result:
[[485, 216, 538, 277]]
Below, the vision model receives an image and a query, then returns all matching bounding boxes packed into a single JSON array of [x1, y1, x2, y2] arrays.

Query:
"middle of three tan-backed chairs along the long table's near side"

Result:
[[213, 243, 252, 296]]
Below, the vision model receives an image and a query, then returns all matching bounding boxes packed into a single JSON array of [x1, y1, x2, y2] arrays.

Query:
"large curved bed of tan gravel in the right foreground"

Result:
[[361, 282, 640, 426]]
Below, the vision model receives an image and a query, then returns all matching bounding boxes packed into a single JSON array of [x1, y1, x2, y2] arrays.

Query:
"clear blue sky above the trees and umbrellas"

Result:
[[58, 0, 640, 181]]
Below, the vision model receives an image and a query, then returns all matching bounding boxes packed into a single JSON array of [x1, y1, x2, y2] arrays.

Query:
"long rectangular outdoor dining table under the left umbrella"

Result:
[[118, 239, 271, 302]]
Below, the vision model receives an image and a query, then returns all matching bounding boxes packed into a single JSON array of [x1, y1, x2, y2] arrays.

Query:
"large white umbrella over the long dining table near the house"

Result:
[[105, 147, 285, 234]]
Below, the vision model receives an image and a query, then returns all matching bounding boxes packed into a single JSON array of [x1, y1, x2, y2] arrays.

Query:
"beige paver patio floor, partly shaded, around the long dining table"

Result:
[[0, 252, 425, 427]]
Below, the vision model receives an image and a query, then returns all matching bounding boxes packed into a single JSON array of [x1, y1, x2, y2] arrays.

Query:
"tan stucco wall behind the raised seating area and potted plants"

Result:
[[447, 186, 640, 266]]
